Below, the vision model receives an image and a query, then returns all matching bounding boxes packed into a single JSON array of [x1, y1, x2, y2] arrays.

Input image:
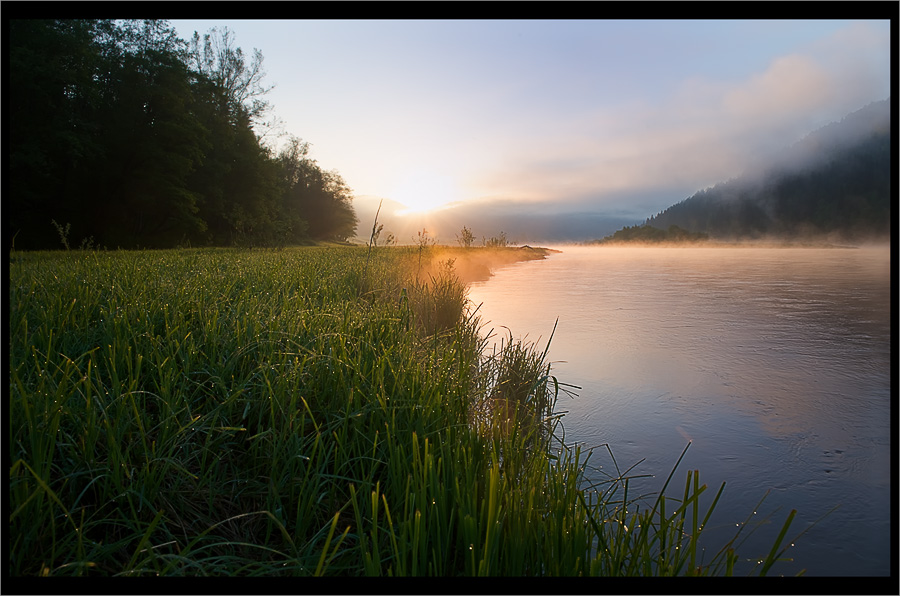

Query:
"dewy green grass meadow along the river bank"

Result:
[[7, 247, 793, 576]]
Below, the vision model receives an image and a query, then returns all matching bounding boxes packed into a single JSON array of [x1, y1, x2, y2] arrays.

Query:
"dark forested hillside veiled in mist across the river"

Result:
[[645, 100, 894, 239]]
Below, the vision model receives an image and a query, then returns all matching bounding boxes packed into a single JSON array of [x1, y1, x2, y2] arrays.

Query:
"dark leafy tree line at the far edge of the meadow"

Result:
[[4, 20, 358, 249]]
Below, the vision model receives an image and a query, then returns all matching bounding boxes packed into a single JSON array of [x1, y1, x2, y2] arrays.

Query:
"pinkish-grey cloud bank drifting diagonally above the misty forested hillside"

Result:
[[481, 23, 890, 214]]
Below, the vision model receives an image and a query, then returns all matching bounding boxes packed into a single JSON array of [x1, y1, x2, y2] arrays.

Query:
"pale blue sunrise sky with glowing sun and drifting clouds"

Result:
[[170, 20, 891, 242]]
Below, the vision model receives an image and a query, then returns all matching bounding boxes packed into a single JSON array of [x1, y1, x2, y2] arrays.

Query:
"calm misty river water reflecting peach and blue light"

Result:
[[469, 247, 892, 576]]
